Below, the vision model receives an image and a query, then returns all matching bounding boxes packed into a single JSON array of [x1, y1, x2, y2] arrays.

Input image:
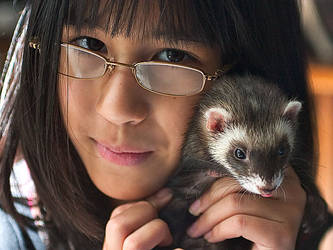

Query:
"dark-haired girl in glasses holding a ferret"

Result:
[[0, 0, 324, 250]]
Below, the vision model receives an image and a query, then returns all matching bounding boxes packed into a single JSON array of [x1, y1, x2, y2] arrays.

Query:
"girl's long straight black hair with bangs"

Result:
[[0, 0, 314, 249]]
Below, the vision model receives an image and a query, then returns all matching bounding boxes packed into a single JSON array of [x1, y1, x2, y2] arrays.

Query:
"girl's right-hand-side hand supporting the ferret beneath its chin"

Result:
[[188, 167, 306, 250]]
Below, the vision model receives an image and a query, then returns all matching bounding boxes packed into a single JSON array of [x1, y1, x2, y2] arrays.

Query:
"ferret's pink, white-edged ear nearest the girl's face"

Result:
[[205, 108, 231, 132]]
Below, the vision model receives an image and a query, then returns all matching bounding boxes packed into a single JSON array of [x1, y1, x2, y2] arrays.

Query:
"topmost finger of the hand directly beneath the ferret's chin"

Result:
[[187, 193, 298, 238]]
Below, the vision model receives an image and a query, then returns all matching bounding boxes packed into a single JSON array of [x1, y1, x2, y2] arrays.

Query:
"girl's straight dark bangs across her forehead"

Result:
[[65, 0, 221, 46]]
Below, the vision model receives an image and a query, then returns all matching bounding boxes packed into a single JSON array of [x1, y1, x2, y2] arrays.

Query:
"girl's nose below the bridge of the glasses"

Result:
[[96, 67, 150, 126]]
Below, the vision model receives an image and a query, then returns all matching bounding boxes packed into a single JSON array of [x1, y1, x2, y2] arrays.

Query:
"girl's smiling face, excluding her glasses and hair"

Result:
[[59, 25, 220, 200]]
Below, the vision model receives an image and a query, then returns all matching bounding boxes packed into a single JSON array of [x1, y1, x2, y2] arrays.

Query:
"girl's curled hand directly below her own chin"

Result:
[[103, 188, 172, 250]]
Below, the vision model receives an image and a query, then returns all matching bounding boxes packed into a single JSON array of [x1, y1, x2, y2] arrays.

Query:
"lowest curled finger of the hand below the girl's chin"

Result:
[[123, 219, 172, 250]]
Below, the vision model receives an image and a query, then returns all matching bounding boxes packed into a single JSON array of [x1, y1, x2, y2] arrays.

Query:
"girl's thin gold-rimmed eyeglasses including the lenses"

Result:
[[30, 40, 231, 96]]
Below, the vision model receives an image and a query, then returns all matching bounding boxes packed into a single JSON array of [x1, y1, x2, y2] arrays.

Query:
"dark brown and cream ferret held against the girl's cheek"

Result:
[[156, 76, 326, 250]]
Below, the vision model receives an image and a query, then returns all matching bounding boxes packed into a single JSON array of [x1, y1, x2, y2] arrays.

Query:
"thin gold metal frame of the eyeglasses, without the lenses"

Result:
[[29, 40, 233, 97]]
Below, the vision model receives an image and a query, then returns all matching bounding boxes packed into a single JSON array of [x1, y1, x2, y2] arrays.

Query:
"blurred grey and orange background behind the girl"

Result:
[[0, 0, 333, 250]]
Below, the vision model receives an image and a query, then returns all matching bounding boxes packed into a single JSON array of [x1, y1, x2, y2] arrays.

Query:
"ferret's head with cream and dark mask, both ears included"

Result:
[[205, 101, 302, 197]]
